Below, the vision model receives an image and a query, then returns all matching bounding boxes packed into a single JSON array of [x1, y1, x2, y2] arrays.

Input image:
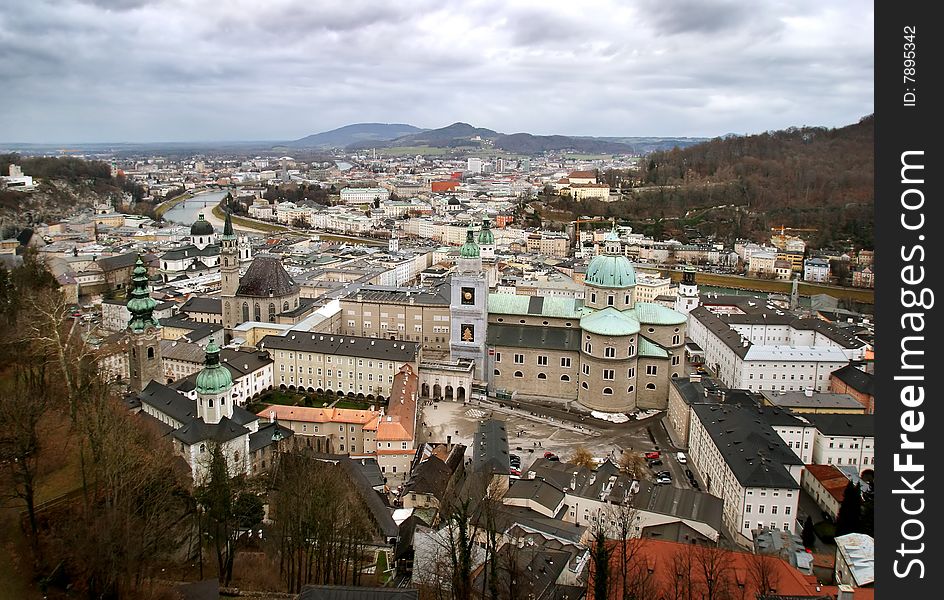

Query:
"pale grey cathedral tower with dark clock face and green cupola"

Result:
[[449, 227, 488, 381]]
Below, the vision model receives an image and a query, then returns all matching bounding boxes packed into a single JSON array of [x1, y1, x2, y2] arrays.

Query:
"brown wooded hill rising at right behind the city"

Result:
[[641, 115, 875, 247]]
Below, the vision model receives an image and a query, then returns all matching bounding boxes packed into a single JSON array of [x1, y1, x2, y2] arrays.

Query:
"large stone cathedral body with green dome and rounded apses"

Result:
[[486, 232, 686, 411]]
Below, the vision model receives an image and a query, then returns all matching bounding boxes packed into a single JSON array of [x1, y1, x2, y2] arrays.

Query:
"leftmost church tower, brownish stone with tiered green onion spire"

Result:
[[127, 256, 164, 392]]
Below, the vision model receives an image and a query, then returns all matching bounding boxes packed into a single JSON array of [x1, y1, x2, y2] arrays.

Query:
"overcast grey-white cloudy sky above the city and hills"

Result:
[[0, 0, 874, 142]]
